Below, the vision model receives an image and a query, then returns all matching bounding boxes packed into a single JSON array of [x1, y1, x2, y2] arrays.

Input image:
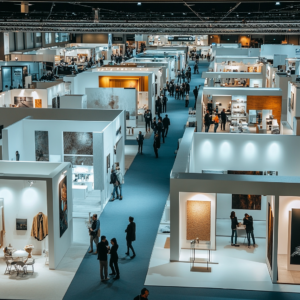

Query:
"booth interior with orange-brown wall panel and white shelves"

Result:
[[196, 87, 286, 133]]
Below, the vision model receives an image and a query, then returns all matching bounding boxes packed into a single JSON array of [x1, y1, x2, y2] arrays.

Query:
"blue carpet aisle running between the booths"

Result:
[[64, 63, 297, 300]]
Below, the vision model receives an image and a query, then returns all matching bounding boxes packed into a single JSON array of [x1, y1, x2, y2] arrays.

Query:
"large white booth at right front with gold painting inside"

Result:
[[145, 128, 300, 292]]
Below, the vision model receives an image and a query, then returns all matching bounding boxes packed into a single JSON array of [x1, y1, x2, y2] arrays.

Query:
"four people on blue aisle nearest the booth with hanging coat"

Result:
[[89, 214, 136, 281]]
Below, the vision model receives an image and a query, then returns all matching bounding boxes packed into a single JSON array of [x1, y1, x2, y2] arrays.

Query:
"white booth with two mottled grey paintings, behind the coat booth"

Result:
[[0, 108, 125, 217]]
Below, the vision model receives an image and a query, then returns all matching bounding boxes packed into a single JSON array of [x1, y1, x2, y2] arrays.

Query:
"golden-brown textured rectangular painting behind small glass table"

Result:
[[186, 200, 211, 241]]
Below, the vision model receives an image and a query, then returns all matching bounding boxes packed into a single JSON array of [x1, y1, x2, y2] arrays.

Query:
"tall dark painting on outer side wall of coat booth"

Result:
[[58, 176, 68, 237]]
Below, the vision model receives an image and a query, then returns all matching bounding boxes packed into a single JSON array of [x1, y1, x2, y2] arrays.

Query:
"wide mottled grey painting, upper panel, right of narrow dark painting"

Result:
[[63, 132, 93, 155]]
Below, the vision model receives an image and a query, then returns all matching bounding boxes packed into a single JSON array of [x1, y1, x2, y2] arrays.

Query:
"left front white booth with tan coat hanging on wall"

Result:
[[0, 160, 73, 269]]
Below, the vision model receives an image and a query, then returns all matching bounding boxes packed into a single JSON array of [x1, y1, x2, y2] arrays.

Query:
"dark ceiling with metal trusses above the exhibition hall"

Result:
[[0, 0, 300, 35]]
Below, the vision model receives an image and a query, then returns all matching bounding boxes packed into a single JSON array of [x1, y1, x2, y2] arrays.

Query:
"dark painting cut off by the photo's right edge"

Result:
[[290, 208, 300, 265]]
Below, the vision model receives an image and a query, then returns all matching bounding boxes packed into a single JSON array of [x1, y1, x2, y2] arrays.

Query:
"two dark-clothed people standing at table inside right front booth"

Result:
[[230, 211, 256, 248]]
